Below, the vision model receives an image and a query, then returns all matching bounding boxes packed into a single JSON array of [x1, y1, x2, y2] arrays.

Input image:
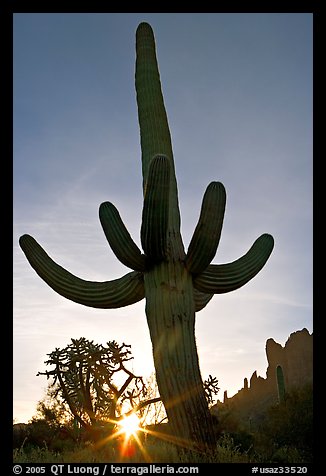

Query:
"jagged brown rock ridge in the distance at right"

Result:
[[211, 328, 313, 426]]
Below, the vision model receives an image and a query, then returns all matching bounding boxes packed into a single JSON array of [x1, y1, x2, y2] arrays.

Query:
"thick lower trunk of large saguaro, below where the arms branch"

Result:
[[145, 261, 215, 450]]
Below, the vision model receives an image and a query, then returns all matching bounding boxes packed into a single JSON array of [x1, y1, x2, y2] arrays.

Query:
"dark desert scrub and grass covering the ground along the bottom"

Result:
[[13, 385, 313, 464]]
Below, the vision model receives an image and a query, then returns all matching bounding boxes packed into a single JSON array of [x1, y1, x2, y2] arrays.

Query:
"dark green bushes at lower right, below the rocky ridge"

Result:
[[215, 384, 313, 463]]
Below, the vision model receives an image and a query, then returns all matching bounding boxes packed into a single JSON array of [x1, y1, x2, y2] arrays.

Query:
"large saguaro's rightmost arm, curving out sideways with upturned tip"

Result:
[[193, 234, 274, 294]]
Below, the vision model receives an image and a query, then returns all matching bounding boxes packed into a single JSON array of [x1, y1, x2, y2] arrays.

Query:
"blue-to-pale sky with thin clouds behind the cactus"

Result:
[[13, 13, 313, 422]]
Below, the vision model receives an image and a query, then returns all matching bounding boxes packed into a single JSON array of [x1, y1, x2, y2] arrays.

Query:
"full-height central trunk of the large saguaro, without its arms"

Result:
[[136, 23, 214, 448]]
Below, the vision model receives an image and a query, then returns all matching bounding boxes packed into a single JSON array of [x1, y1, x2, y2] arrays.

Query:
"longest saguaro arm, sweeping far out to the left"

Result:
[[19, 235, 145, 309]]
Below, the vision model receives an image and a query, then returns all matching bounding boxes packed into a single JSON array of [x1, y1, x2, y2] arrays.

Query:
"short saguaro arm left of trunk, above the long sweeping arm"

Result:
[[99, 202, 146, 271]]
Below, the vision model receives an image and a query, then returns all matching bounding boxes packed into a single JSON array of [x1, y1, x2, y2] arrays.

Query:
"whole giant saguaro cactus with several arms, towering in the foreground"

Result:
[[20, 23, 274, 447]]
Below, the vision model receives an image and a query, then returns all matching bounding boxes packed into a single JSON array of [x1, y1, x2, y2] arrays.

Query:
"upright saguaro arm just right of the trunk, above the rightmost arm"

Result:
[[185, 182, 226, 274]]
